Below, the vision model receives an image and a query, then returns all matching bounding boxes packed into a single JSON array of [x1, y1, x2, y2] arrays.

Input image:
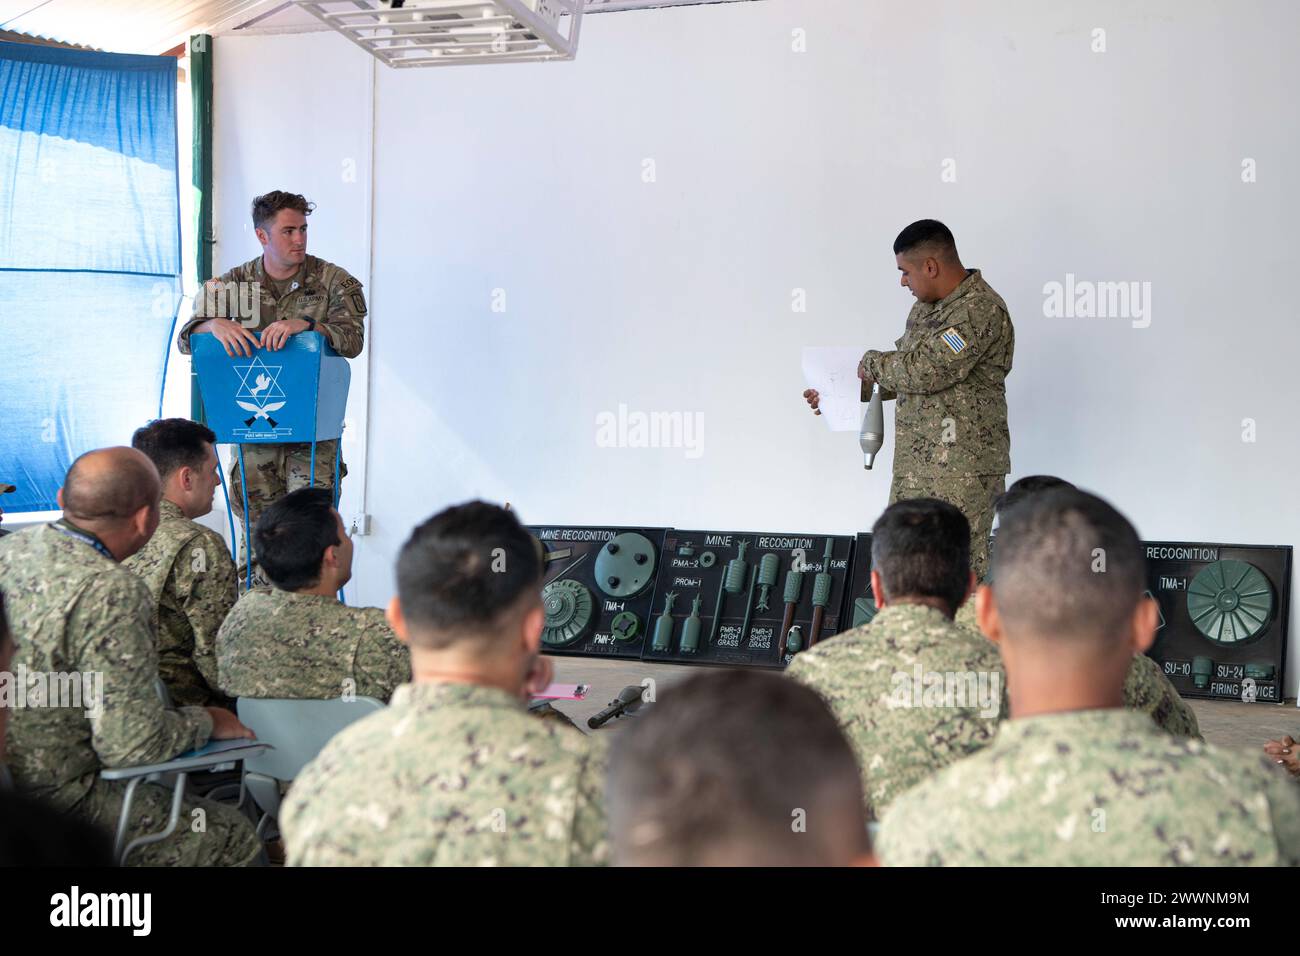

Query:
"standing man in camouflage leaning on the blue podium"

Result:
[[177, 190, 365, 574]]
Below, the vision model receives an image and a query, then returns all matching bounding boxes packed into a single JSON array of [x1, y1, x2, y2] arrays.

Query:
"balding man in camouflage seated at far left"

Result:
[[0, 449, 261, 866]]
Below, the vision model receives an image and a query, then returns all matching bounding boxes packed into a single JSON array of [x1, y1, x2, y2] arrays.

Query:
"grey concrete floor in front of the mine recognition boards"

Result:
[[553, 656, 1300, 750]]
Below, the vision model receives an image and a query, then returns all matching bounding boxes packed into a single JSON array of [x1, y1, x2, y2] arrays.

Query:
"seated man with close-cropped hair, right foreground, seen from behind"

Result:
[[878, 489, 1300, 866]]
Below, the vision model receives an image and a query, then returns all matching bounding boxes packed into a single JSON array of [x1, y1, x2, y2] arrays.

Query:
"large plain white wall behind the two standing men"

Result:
[[216, 0, 1300, 693]]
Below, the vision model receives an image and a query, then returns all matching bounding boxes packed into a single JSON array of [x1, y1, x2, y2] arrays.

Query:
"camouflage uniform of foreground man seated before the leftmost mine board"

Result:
[[280, 683, 608, 866]]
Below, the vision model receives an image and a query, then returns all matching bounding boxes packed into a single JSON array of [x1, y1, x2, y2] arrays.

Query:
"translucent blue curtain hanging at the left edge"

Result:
[[0, 43, 181, 511]]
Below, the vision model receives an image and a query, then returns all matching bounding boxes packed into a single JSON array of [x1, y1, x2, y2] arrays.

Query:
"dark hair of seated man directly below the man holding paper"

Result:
[[871, 498, 971, 617]]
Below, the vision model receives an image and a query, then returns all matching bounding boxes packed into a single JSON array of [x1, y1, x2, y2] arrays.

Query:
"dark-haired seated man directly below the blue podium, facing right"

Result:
[[217, 488, 411, 701]]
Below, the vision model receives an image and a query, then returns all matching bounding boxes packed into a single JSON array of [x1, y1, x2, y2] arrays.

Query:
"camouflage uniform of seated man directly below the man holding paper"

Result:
[[785, 604, 1006, 819]]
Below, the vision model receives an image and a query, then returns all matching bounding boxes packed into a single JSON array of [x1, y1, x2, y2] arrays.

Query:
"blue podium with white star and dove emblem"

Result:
[[190, 332, 352, 587]]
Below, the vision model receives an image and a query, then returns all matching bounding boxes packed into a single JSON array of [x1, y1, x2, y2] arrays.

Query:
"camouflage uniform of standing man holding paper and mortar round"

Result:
[[862, 269, 1015, 578]]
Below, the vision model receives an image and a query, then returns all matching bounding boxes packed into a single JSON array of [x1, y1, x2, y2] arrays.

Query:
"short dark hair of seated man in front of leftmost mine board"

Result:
[[397, 501, 542, 648]]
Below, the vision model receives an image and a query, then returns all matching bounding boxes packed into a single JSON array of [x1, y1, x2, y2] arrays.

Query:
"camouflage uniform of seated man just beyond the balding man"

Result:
[[122, 498, 235, 708]]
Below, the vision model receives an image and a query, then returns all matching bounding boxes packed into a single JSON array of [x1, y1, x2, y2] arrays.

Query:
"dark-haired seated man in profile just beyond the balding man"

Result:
[[122, 419, 237, 706]]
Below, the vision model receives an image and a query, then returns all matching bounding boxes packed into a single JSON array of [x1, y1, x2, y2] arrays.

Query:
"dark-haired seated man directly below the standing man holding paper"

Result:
[[785, 498, 1005, 819]]
